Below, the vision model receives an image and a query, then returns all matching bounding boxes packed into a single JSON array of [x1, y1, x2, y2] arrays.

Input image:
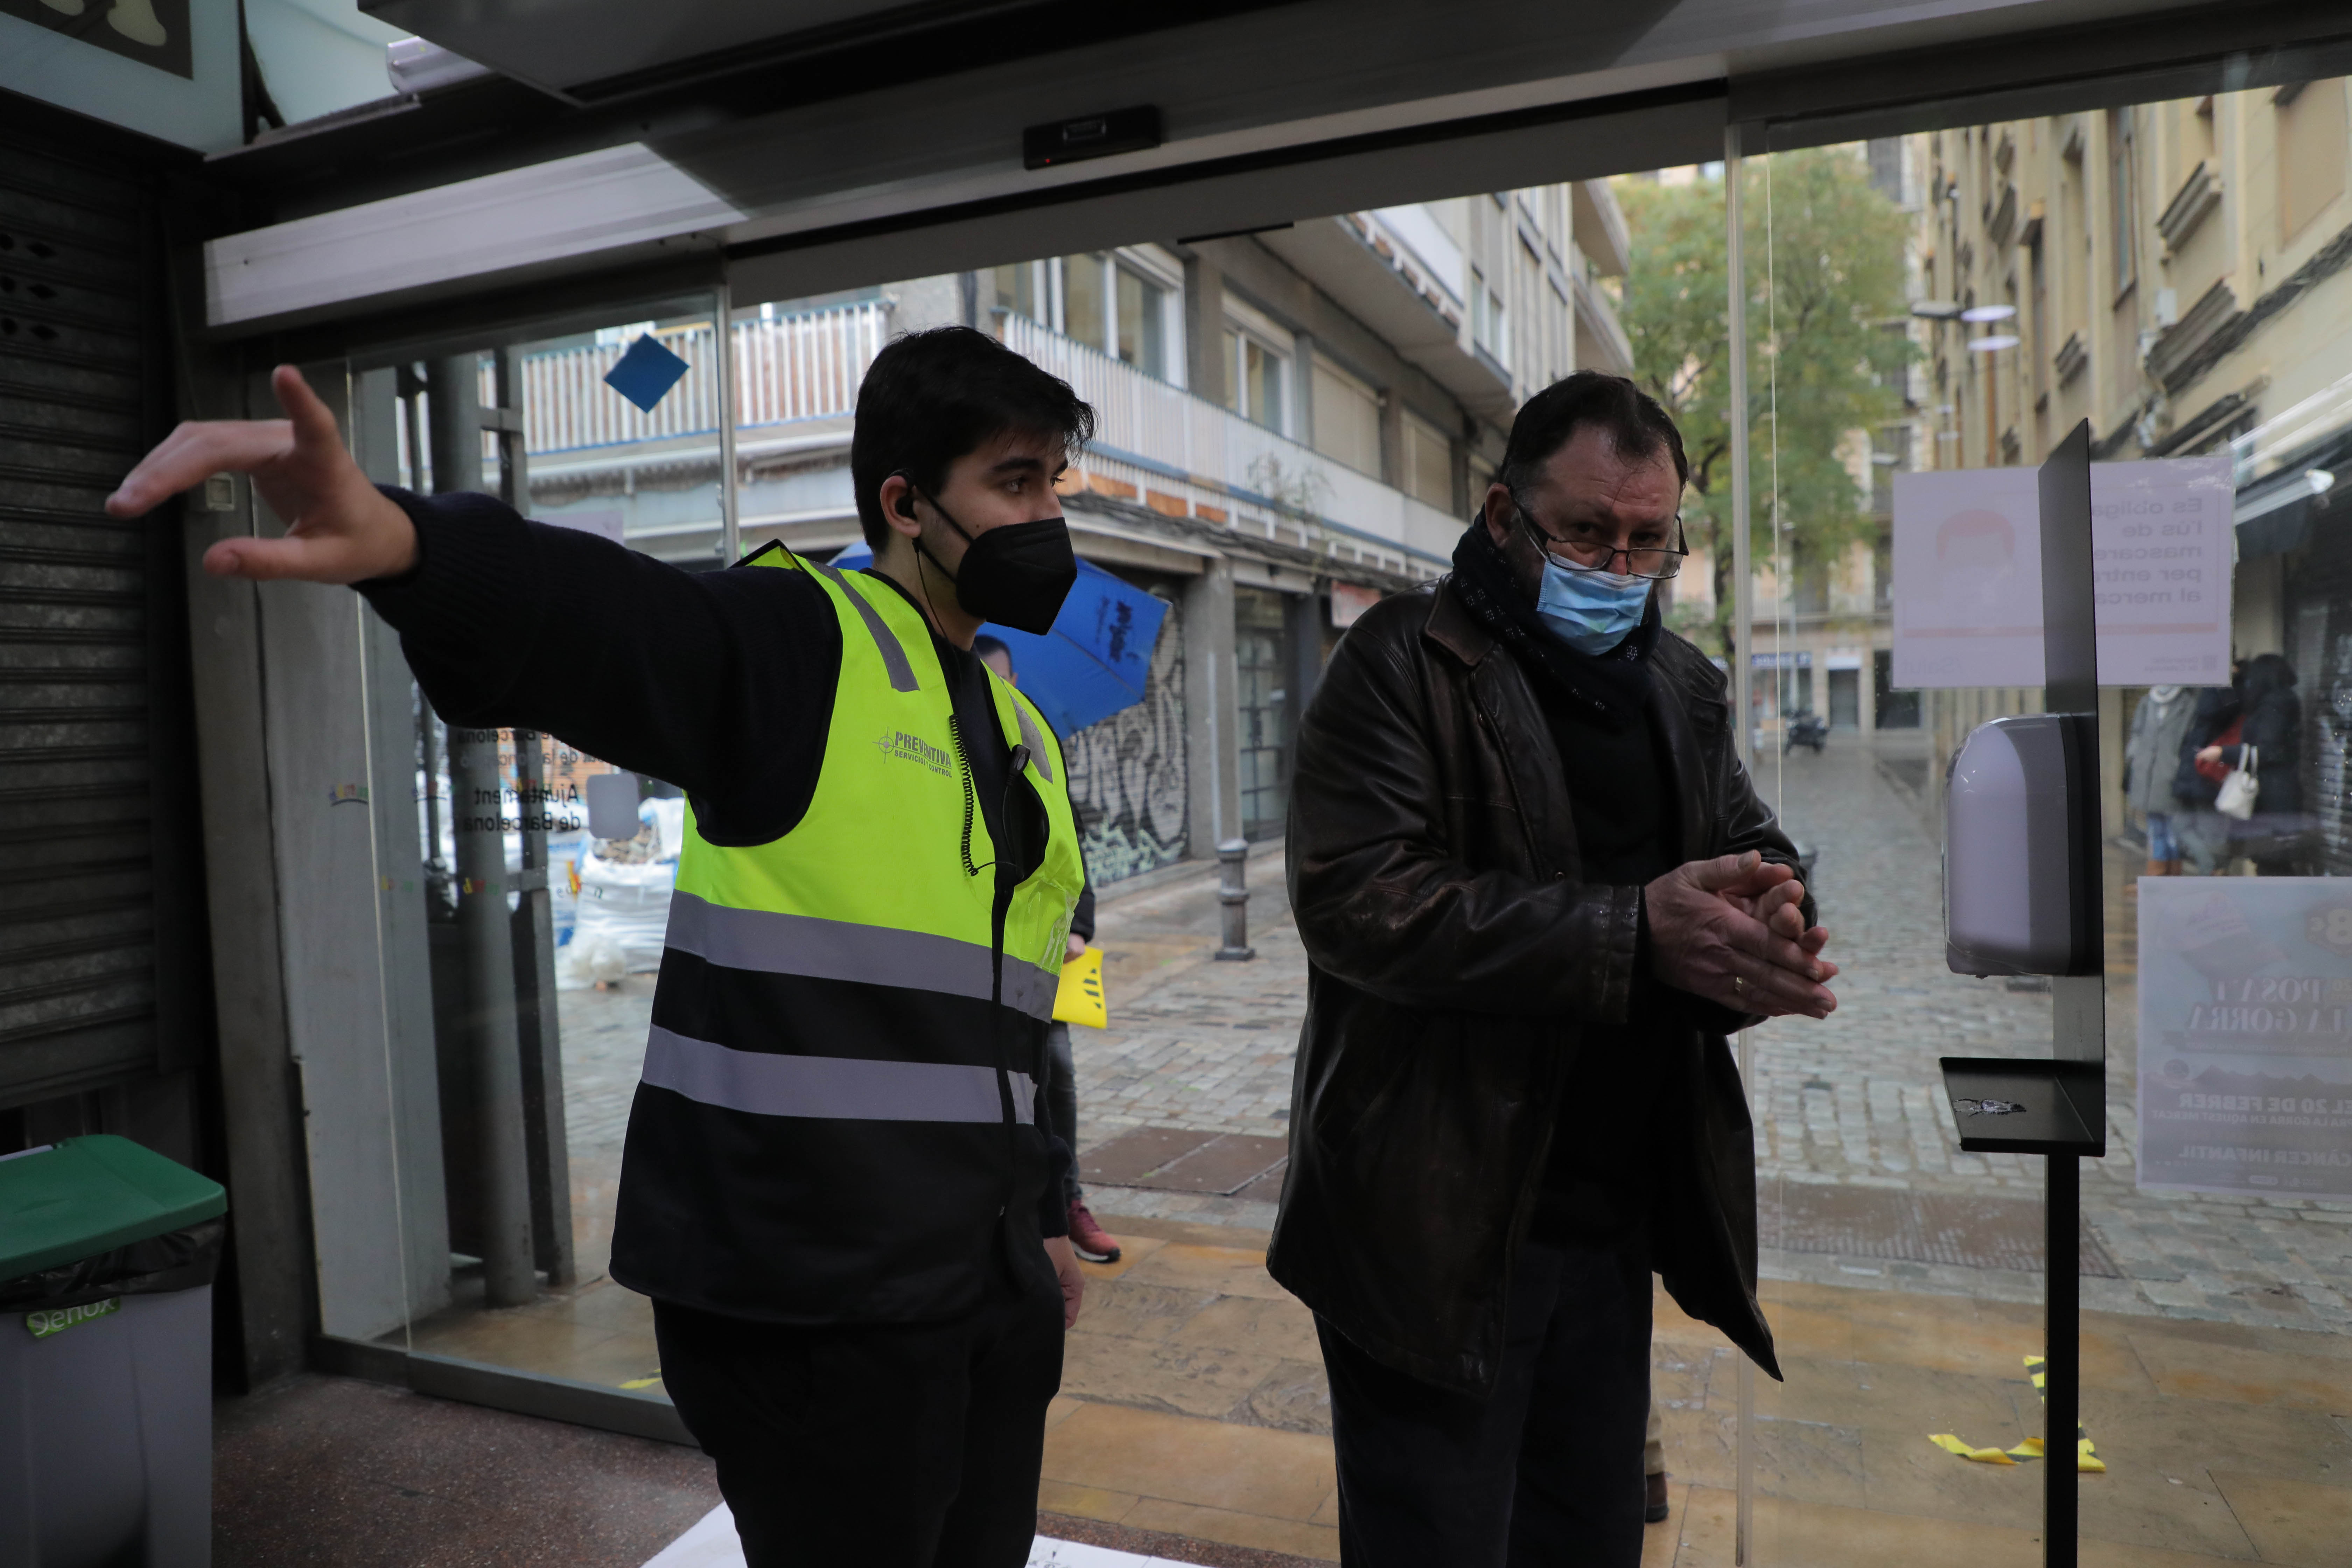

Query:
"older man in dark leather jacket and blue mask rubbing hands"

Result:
[[1268, 371, 1837, 1568]]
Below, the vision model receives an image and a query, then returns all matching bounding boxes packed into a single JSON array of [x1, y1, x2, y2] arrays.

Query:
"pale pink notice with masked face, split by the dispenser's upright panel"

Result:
[[1893, 458, 2234, 689]]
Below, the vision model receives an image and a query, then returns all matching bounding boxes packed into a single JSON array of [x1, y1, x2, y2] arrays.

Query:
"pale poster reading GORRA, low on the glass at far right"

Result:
[[2140, 877, 2352, 1199]]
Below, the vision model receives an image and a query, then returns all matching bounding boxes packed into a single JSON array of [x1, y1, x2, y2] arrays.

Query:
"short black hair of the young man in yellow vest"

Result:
[[849, 327, 1094, 555]]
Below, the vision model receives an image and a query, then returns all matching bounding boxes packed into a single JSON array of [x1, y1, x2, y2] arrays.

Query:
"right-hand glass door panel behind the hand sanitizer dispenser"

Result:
[[1745, 80, 2352, 1566]]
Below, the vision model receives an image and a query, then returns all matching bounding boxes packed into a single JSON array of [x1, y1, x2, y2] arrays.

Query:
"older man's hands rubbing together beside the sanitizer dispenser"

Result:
[[1646, 851, 1837, 1018]]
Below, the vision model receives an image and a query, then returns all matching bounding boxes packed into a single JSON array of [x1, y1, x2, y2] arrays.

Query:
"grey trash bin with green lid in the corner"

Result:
[[0, 1133, 228, 1568]]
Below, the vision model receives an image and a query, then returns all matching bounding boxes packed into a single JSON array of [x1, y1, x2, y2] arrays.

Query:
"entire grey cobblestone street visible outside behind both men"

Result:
[[541, 736, 2352, 1331]]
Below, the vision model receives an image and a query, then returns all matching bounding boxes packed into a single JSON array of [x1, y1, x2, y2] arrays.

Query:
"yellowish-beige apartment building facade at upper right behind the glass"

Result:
[[1905, 78, 2352, 841]]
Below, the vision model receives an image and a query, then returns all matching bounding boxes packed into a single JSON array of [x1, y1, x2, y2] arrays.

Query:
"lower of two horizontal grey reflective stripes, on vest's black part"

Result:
[[644, 1025, 1037, 1124]]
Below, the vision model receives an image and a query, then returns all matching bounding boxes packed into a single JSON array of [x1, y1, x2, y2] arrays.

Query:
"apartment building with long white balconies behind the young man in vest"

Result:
[[491, 181, 1630, 882]]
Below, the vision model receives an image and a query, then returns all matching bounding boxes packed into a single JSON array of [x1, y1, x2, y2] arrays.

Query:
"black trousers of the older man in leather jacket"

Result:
[[1315, 1241, 1649, 1568]]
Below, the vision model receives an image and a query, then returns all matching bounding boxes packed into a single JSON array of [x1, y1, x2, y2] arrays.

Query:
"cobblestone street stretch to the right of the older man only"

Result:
[[1752, 738, 2352, 1331]]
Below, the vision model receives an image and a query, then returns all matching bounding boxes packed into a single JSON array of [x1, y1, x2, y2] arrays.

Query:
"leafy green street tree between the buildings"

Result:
[[1616, 148, 1914, 658]]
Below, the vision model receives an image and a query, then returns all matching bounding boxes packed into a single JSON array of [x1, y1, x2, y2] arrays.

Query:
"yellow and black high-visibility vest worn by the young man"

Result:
[[611, 545, 1084, 1323]]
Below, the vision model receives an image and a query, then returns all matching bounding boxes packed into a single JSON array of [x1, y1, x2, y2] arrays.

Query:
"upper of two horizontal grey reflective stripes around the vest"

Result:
[[668, 893, 1061, 1023]]
